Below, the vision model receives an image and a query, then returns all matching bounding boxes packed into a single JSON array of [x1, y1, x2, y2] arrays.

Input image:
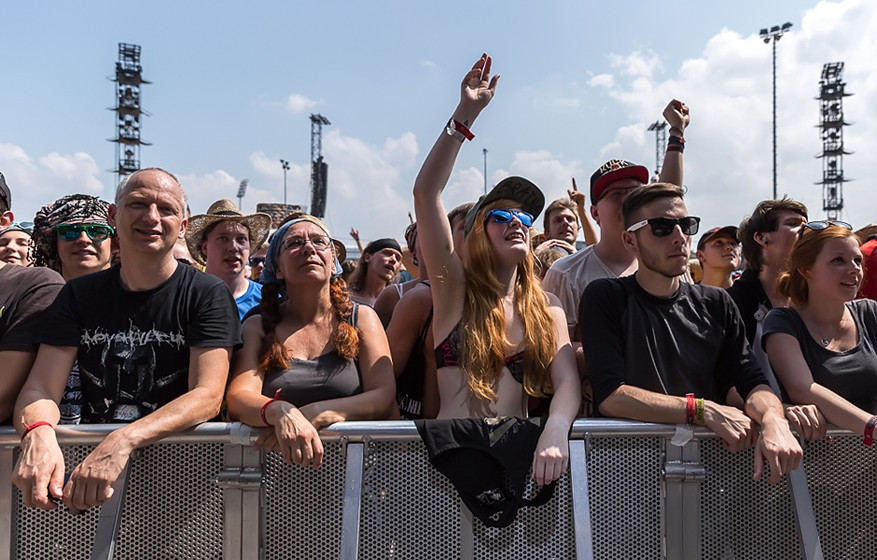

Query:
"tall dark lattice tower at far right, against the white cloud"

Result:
[[816, 62, 852, 220]]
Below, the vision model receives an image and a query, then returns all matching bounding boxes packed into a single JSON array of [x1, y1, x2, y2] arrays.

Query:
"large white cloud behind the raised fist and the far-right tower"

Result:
[[590, 0, 877, 227]]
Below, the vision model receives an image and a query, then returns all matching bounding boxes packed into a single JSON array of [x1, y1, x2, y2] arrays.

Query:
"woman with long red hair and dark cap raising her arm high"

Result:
[[414, 54, 581, 484]]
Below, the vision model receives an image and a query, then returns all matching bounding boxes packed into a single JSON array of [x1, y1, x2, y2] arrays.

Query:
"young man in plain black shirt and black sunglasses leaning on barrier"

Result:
[[580, 183, 802, 483]]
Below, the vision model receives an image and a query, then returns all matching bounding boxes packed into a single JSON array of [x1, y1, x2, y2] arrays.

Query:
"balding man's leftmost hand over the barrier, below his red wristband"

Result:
[[12, 426, 64, 510]]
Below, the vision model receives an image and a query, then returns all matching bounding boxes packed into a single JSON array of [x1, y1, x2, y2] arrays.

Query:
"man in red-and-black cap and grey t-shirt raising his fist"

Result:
[[542, 99, 690, 415]]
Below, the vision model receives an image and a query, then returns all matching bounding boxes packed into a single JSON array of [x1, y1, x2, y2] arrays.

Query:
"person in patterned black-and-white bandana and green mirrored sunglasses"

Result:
[[32, 194, 115, 424]]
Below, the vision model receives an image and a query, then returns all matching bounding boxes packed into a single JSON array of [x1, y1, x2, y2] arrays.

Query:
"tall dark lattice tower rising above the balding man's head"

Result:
[[109, 43, 152, 181]]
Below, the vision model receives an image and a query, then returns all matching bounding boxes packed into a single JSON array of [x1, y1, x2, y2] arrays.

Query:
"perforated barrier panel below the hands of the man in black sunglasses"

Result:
[[700, 438, 802, 560]]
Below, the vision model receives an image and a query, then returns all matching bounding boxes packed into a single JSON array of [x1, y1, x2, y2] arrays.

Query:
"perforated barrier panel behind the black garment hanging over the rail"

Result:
[[360, 440, 575, 560]]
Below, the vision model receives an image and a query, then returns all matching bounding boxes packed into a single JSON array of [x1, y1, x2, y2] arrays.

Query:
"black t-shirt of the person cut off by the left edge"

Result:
[[0, 264, 64, 352]]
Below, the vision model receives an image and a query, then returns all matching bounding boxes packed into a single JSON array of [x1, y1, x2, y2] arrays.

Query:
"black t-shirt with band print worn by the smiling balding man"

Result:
[[40, 265, 241, 423]]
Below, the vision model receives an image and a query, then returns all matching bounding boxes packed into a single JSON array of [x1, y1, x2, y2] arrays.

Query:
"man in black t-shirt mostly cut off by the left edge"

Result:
[[0, 173, 64, 423]]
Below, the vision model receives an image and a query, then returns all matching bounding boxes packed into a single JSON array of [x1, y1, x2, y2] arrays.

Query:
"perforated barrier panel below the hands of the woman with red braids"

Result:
[[263, 442, 345, 560]]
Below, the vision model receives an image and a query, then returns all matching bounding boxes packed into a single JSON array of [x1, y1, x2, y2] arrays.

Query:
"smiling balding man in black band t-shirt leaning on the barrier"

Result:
[[12, 169, 241, 509]]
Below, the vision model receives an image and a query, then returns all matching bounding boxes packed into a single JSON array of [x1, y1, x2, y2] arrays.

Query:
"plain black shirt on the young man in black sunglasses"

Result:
[[579, 275, 767, 407]]
